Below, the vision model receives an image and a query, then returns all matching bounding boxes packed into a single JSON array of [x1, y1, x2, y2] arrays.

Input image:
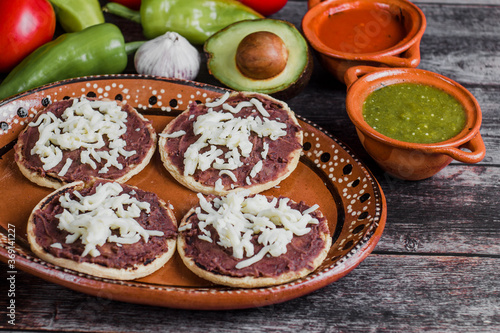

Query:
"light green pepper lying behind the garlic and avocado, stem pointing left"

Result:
[[104, 0, 263, 45]]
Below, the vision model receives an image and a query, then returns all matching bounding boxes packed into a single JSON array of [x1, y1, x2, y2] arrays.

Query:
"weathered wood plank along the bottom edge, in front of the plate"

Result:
[[0, 255, 500, 332]]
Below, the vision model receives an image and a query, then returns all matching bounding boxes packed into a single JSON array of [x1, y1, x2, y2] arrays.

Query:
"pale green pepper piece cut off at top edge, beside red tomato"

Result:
[[50, 0, 104, 32]]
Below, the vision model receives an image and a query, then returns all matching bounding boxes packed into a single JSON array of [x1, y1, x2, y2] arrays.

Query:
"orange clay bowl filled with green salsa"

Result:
[[345, 66, 486, 180]]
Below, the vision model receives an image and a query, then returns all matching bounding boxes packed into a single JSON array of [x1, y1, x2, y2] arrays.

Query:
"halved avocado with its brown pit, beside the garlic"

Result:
[[203, 19, 313, 100]]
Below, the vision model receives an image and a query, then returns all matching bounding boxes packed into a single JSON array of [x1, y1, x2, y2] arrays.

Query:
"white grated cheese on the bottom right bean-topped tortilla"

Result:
[[193, 191, 319, 269]]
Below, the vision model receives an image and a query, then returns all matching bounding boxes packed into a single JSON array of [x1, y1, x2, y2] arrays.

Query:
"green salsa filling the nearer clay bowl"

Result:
[[363, 83, 466, 143]]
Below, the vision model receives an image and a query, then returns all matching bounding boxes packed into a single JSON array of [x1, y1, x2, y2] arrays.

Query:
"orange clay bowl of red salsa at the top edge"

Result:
[[302, 0, 426, 82]]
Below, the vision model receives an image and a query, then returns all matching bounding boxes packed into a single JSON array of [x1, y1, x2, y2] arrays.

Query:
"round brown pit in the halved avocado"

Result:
[[236, 31, 288, 80]]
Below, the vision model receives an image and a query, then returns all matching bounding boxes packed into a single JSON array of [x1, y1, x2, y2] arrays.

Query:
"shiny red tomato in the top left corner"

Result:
[[0, 0, 56, 73]]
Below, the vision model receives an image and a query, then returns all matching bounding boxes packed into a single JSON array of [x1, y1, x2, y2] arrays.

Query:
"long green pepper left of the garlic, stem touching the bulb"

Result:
[[0, 23, 143, 100]]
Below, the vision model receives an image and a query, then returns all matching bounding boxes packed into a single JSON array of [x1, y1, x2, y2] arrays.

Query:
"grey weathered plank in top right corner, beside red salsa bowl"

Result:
[[420, 5, 500, 85]]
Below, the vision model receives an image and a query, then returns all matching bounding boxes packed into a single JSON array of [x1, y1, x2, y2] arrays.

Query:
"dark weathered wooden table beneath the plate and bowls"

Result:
[[0, 0, 500, 332]]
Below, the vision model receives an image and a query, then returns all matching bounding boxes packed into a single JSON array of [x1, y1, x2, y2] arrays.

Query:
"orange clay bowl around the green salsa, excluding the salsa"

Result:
[[345, 66, 486, 180]]
